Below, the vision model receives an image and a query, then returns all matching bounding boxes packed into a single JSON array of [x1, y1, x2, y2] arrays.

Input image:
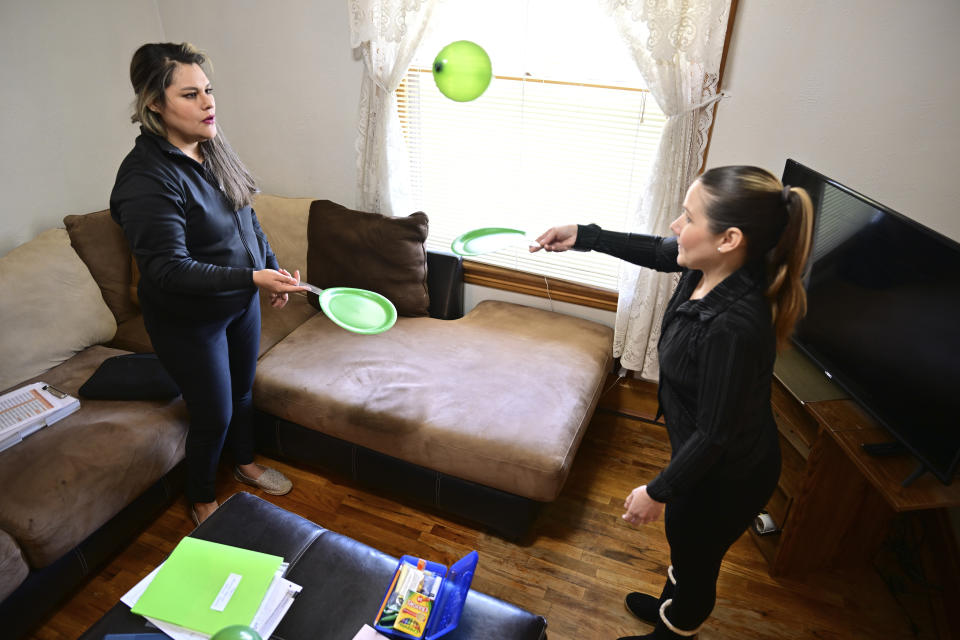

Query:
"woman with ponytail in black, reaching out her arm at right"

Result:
[[531, 166, 813, 640]]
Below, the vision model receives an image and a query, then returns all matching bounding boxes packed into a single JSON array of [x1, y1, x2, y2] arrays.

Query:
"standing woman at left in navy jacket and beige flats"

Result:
[[110, 43, 304, 524]]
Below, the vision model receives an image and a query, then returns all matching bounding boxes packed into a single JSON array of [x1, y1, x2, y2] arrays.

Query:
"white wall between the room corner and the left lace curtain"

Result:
[[157, 0, 363, 206]]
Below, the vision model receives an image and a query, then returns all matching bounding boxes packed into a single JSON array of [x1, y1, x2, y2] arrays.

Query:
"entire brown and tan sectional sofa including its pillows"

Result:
[[0, 195, 612, 637]]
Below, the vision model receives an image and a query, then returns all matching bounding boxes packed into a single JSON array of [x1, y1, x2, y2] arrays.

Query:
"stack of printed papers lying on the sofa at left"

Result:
[[0, 382, 80, 451]]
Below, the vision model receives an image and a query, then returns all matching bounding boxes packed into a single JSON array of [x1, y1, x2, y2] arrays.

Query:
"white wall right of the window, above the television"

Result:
[[707, 0, 960, 240]]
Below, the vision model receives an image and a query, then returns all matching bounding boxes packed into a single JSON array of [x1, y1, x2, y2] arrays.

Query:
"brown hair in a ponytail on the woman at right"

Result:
[[699, 166, 813, 348]]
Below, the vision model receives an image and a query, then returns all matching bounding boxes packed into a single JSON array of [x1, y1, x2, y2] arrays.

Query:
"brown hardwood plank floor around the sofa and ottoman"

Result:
[[31, 381, 949, 640]]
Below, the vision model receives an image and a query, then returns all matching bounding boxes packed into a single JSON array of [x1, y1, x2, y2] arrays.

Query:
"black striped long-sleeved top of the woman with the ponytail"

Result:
[[574, 225, 780, 502]]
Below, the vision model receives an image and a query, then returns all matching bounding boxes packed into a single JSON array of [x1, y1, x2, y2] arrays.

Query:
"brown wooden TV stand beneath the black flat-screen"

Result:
[[751, 348, 960, 576]]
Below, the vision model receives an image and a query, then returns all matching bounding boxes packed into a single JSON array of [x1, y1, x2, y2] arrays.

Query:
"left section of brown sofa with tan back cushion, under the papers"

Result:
[[0, 229, 187, 638]]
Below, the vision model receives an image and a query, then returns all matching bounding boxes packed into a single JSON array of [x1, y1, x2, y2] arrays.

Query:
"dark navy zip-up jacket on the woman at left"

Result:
[[110, 128, 278, 309]]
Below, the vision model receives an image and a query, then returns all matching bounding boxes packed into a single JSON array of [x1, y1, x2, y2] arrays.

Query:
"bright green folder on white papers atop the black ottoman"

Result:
[[120, 537, 301, 640]]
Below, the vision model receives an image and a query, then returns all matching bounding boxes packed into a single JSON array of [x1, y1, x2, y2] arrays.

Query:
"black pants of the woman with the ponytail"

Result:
[[664, 452, 780, 630]]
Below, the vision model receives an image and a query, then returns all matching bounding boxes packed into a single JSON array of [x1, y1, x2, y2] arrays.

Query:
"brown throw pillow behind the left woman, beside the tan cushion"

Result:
[[63, 209, 140, 323]]
